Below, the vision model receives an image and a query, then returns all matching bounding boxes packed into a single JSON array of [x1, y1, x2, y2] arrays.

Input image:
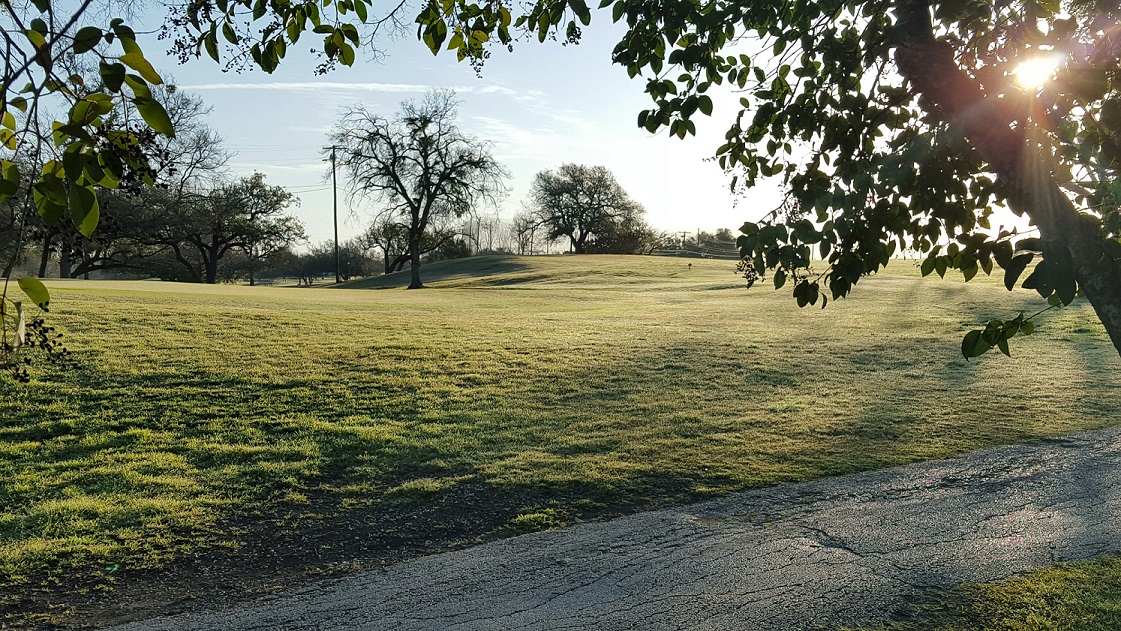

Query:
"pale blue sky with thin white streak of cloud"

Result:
[[128, 11, 779, 243]]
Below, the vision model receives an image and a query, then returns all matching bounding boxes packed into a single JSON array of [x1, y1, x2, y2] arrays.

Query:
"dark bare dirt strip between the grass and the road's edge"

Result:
[[0, 482, 651, 630]]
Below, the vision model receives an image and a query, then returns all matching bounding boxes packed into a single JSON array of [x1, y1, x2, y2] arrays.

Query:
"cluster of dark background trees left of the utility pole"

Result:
[[0, 89, 306, 284]]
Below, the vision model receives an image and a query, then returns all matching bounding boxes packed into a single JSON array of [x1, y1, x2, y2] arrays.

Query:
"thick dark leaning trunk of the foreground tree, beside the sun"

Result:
[[896, 0, 1121, 353]]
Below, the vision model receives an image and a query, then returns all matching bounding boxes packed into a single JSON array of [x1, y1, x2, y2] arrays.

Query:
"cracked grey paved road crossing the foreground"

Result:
[[105, 428, 1121, 631]]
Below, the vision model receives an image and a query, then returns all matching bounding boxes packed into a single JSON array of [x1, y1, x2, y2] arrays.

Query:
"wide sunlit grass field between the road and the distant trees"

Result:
[[0, 257, 1121, 624]]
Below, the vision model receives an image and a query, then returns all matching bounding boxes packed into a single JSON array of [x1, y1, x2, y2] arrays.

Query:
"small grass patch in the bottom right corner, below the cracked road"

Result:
[[849, 558, 1121, 631]]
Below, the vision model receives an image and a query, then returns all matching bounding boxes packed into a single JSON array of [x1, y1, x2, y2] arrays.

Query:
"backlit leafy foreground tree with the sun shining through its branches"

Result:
[[392, 0, 1121, 356]]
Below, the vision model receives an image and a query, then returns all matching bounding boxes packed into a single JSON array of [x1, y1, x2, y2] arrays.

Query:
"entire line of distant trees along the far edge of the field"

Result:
[[0, 87, 699, 285]]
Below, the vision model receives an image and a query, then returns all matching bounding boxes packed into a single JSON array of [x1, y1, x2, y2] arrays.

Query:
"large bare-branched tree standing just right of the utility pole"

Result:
[[332, 91, 509, 289]]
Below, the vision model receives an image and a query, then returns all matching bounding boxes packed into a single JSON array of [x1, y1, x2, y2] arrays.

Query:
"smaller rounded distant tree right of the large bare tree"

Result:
[[529, 164, 646, 254]]
